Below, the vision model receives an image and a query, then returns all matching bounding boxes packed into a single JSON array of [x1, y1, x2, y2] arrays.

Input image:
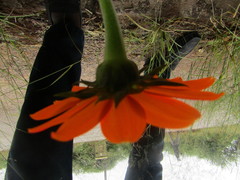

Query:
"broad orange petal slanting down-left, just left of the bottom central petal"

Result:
[[51, 97, 112, 141]]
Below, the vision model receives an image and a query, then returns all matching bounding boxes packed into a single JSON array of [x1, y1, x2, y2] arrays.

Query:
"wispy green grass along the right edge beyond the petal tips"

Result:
[[188, 14, 240, 124]]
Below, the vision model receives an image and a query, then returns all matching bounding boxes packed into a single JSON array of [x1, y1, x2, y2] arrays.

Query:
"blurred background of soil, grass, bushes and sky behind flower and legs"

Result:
[[0, 0, 240, 180]]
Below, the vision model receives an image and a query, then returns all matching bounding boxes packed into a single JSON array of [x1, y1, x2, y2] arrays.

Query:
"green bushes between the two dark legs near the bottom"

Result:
[[73, 141, 131, 173]]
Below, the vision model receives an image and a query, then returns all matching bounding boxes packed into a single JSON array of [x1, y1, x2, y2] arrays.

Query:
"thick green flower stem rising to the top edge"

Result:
[[99, 0, 127, 63]]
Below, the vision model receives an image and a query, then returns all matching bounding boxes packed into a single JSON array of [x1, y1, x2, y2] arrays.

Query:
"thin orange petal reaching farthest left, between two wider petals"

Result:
[[28, 98, 96, 133]]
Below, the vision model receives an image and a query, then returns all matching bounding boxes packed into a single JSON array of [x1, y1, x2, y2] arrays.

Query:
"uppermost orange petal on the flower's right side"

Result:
[[168, 77, 215, 90]]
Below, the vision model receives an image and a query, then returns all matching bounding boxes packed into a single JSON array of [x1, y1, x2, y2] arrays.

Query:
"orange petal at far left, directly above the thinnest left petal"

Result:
[[30, 97, 81, 120]]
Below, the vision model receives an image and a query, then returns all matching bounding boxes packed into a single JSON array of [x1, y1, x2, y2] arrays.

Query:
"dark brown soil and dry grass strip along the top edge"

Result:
[[0, 0, 240, 45]]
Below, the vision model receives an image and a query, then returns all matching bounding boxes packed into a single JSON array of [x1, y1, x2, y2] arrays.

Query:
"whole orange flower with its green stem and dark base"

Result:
[[29, 0, 223, 143]]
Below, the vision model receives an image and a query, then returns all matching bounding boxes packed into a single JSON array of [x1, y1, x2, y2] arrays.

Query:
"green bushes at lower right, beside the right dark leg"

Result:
[[165, 125, 240, 166]]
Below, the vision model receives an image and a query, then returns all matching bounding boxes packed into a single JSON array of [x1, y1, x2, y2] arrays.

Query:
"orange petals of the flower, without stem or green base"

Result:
[[29, 78, 223, 143]]
